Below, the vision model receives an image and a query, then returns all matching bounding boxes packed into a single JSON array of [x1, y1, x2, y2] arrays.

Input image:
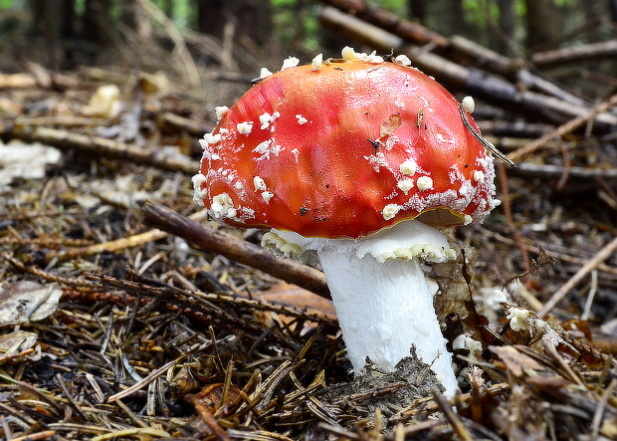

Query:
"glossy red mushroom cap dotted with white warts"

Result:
[[194, 60, 495, 238]]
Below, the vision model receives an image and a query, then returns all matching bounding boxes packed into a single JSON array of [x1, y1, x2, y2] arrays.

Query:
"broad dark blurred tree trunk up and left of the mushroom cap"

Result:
[[197, 0, 272, 46]]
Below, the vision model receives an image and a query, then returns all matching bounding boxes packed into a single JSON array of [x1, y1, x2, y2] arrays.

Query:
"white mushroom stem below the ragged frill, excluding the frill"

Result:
[[317, 248, 458, 396]]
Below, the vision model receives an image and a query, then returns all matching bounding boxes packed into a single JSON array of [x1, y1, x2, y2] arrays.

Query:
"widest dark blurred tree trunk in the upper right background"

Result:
[[525, 0, 560, 50]]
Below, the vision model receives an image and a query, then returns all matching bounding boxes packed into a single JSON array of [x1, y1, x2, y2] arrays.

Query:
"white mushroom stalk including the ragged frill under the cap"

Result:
[[264, 221, 458, 397]]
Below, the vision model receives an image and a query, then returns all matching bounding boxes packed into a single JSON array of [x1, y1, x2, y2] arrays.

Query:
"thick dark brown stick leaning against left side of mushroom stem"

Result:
[[144, 203, 330, 299]]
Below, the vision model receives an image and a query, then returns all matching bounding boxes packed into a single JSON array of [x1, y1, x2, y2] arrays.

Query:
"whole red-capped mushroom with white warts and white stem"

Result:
[[193, 48, 498, 395]]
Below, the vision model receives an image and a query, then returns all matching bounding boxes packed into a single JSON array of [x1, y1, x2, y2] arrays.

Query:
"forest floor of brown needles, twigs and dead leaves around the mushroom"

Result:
[[0, 25, 617, 440]]
